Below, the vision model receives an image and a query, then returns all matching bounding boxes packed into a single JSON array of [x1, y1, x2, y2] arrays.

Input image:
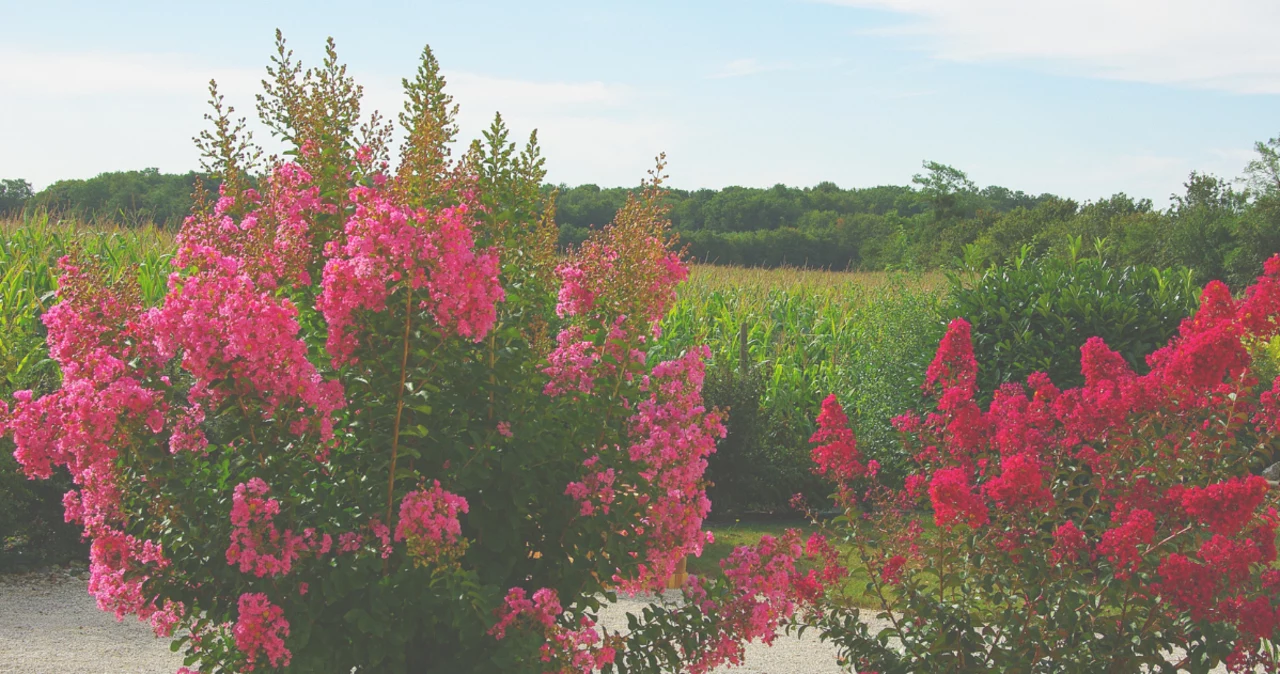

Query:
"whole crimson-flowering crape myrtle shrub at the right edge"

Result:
[[809, 256, 1280, 674]]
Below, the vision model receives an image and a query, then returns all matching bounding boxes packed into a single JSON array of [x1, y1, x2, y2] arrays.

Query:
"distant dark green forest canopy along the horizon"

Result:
[[0, 138, 1280, 285]]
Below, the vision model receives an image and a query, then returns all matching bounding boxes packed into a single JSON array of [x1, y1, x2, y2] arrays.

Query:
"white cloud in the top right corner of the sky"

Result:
[[817, 0, 1280, 93]]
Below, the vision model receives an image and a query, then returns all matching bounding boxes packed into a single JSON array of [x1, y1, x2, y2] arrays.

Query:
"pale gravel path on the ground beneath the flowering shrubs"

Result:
[[0, 570, 860, 674]]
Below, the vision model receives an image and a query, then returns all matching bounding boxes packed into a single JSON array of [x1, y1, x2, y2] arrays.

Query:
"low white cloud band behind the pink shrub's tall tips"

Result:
[[0, 47, 677, 189]]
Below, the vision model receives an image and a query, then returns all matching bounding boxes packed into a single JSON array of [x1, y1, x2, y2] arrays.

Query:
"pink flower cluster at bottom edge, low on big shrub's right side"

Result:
[[489, 587, 617, 674]]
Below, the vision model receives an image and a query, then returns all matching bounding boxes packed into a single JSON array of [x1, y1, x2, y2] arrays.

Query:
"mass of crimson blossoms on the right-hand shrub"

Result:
[[814, 256, 1280, 666]]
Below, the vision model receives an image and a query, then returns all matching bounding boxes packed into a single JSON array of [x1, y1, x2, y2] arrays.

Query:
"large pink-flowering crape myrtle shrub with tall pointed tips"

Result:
[[0, 37, 822, 673]]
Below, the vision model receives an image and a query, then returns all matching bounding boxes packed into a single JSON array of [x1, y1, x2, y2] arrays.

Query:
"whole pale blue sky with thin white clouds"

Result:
[[0, 0, 1280, 205]]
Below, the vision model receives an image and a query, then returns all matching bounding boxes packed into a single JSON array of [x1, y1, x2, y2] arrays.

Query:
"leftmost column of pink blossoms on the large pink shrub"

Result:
[[0, 258, 184, 634]]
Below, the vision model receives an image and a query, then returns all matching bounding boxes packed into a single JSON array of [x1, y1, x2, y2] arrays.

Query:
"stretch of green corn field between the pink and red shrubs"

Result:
[[654, 267, 946, 503]]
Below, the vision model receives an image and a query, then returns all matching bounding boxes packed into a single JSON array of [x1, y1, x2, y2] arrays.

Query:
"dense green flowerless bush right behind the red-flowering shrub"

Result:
[[943, 245, 1197, 400]]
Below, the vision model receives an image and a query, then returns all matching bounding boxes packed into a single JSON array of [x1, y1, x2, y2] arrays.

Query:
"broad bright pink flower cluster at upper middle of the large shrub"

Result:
[[316, 185, 503, 364]]
